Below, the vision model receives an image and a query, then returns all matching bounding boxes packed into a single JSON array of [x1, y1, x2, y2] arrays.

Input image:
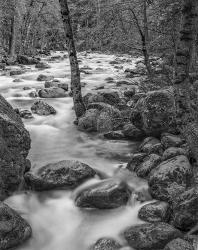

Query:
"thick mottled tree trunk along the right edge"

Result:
[[174, 0, 198, 163]]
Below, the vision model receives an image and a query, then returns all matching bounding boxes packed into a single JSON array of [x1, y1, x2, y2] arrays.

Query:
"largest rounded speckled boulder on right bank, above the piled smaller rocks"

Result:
[[131, 89, 176, 136]]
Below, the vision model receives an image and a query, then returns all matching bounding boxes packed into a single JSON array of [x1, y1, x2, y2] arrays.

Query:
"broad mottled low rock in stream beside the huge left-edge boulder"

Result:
[[25, 160, 96, 191]]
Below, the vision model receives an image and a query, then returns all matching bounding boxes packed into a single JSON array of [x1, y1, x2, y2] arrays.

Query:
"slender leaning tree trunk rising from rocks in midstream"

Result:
[[59, 0, 85, 118]]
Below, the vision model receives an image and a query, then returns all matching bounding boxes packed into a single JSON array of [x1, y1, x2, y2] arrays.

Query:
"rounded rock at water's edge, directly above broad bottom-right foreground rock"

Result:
[[138, 201, 170, 223]]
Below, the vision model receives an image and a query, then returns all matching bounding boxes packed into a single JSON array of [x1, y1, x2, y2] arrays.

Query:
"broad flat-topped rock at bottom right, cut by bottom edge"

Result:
[[124, 222, 182, 250]]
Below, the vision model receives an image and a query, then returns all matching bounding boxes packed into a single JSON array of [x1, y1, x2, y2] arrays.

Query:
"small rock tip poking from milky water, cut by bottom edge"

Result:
[[91, 238, 121, 250]]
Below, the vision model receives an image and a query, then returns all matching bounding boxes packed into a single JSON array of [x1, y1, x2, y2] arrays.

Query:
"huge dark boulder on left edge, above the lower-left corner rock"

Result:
[[0, 96, 30, 200]]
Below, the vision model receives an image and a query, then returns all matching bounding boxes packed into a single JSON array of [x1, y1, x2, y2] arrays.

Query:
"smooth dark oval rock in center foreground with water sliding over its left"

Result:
[[76, 180, 131, 209]]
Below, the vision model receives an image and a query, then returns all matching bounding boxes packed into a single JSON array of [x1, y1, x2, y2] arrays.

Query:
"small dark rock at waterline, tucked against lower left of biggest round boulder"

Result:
[[122, 124, 145, 140]]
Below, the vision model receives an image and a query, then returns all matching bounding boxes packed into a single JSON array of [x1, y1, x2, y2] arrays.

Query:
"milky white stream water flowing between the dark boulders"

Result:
[[0, 51, 147, 250]]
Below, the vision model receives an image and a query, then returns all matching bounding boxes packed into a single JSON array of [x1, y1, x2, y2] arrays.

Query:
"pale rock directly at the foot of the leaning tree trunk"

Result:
[[78, 109, 99, 132]]
